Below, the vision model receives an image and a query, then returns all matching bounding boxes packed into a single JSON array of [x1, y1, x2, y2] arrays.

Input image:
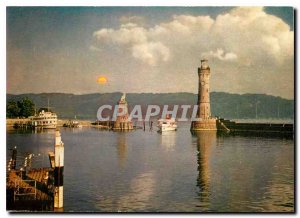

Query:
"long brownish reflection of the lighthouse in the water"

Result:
[[192, 131, 217, 208]]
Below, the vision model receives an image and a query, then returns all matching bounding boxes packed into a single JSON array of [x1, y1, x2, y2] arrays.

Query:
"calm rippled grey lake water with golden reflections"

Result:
[[7, 123, 294, 212]]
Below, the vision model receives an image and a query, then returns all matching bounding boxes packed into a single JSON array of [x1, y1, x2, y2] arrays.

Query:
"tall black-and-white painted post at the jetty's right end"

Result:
[[54, 130, 64, 212]]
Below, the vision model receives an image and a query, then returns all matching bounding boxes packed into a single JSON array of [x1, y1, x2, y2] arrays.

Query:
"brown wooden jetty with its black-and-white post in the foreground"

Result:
[[6, 130, 64, 212]]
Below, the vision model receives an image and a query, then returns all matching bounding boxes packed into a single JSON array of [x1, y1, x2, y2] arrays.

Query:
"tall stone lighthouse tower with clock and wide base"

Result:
[[191, 60, 217, 131]]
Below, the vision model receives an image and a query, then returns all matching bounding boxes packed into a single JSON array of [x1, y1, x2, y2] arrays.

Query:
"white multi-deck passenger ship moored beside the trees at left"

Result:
[[29, 110, 57, 129]]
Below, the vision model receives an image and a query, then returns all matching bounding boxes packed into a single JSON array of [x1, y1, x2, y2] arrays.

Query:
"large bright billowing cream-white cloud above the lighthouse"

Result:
[[94, 7, 293, 66]]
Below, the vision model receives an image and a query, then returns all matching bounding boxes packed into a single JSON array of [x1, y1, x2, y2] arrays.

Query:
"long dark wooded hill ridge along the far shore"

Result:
[[7, 92, 294, 120]]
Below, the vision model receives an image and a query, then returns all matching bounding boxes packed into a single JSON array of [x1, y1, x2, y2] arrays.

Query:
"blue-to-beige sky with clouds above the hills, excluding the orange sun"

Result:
[[6, 7, 294, 99]]
